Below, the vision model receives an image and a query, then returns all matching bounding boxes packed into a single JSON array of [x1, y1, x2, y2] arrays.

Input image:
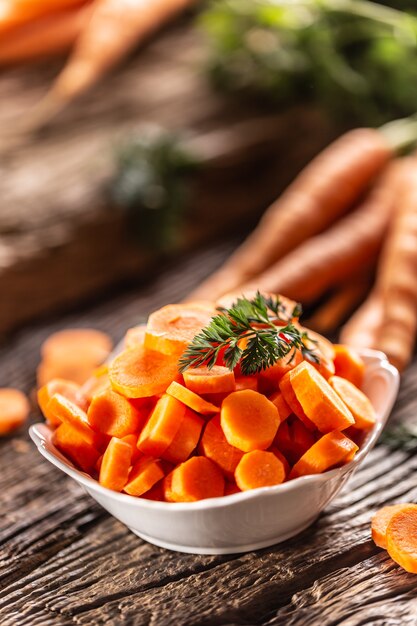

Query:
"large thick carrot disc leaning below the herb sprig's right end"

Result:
[[290, 361, 355, 433]]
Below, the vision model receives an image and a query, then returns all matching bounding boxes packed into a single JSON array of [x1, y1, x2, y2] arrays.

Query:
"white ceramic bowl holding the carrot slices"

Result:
[[29, 350, 399, 554]]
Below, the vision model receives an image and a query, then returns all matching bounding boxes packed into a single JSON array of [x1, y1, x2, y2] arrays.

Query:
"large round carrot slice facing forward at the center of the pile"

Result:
[[220, 389, 280, 452]]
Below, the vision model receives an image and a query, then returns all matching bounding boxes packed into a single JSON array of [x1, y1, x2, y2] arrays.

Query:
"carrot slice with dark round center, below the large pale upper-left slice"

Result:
[[87, 389, 147, 437]]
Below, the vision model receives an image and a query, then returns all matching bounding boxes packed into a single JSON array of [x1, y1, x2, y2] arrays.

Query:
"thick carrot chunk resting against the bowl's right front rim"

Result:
[[290, 430, 359, 478]]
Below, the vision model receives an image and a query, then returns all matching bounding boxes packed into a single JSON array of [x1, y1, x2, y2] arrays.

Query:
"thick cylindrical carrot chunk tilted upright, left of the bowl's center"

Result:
[[138, 394, 187, 457]]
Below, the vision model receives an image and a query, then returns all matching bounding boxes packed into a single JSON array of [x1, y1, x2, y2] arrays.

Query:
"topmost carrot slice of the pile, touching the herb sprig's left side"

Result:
[[145, 303, 216, 356]]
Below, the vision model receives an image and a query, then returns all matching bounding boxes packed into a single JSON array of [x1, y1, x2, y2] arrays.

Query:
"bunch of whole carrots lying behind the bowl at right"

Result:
[[189, 119, 417, 371]]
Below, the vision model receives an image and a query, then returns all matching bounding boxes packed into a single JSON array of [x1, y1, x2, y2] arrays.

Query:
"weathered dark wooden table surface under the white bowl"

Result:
[[0, 243, 417, 626]]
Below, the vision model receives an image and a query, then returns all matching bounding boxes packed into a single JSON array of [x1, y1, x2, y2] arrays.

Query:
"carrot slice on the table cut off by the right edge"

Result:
[[387, 505, 417, 574]]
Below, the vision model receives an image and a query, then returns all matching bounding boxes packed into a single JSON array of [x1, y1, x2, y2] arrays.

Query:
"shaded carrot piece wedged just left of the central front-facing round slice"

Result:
[[198, 416, 243, 479]]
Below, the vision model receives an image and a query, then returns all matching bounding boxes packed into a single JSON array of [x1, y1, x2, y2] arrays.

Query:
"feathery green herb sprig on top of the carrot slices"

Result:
[[179, 292, 319, 375]]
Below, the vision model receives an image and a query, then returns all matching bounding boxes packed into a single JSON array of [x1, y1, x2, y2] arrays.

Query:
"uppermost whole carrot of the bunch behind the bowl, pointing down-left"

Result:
[[191, 128, 392, 299]]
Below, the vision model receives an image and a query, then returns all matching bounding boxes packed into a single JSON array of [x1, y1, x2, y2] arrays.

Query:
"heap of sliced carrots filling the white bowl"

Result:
[[38, 302, 375, 502]]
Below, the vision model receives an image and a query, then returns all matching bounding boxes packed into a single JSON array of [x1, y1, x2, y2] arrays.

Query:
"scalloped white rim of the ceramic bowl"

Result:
[[29, 349, 400, 512]]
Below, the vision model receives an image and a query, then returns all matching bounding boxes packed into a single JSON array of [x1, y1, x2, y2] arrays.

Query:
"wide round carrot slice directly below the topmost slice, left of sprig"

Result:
[[109, 346, 180, 398]]
